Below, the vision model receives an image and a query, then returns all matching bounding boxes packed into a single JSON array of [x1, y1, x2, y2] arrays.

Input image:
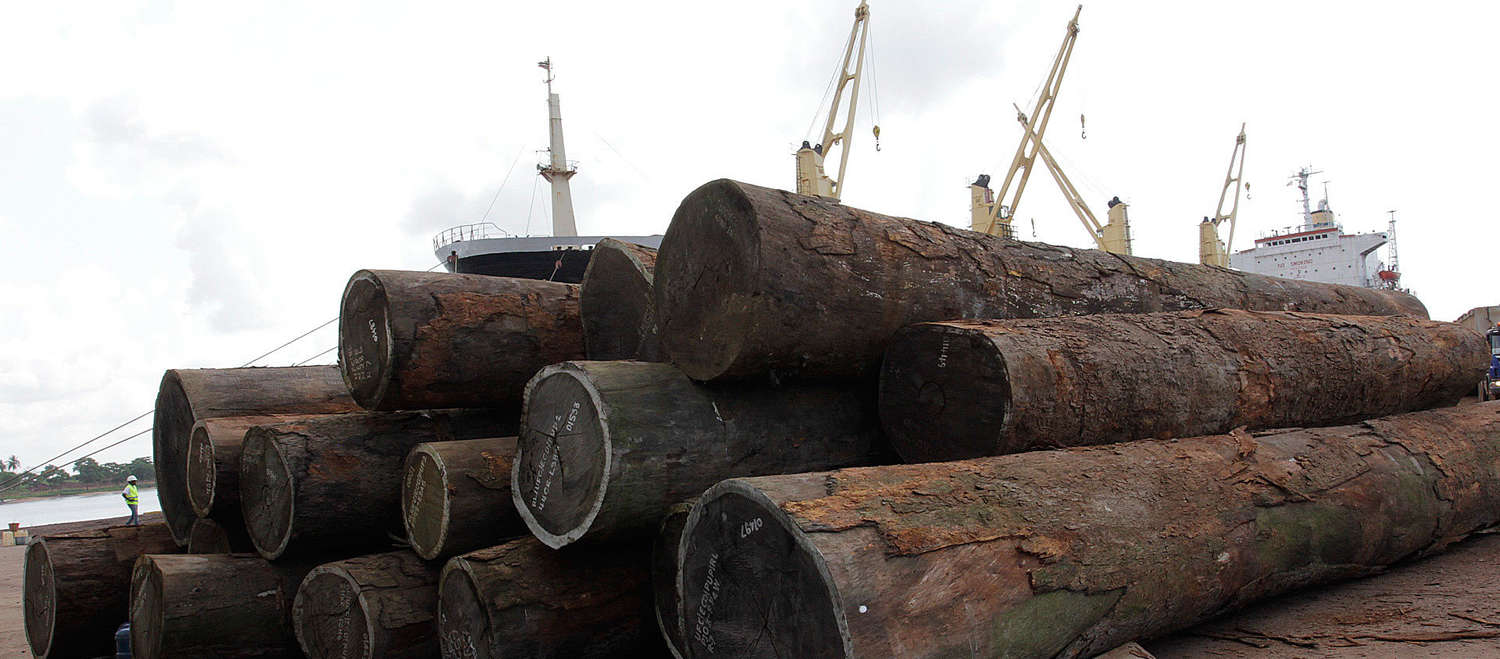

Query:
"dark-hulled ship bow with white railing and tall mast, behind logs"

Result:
[[432, 57, 662, 284]]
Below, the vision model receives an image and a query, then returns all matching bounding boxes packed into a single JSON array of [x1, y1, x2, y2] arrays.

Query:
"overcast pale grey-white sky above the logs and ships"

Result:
[[0, 0, 1500, 465]]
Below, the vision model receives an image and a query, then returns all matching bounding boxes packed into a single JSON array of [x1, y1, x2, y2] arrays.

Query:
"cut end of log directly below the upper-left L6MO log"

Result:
[[240, 428, 296, 560]]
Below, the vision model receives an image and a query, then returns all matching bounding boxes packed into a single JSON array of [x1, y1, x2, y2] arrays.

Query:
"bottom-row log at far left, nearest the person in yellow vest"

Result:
[[21, 522, 177, 657]]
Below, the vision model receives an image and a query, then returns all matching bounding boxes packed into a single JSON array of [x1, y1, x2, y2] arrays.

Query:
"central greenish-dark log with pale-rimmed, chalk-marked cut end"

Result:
[[510, 362, 890, 548]]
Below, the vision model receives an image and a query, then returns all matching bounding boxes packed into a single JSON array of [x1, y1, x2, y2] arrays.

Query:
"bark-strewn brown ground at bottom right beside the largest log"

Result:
[[1142, 534, 1500, 659]]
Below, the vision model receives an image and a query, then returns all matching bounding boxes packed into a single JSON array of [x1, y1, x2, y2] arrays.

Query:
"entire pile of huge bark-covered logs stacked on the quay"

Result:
[[38, 180, 1500, 657]]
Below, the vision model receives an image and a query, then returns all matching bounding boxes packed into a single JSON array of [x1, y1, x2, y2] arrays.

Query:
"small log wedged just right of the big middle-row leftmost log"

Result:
[[188, 414, 339, 531]]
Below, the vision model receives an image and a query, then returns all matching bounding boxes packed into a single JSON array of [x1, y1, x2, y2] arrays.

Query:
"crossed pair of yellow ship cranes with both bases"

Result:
[[969, 5, 1131, 254]]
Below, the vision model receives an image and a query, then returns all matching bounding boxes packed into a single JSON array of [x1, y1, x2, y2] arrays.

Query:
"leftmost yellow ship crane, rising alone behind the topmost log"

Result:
[[795, 0, 881, 201]]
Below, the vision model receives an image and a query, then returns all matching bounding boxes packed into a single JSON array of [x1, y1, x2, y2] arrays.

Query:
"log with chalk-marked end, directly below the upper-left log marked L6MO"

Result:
[[240, 410, 516, 560]]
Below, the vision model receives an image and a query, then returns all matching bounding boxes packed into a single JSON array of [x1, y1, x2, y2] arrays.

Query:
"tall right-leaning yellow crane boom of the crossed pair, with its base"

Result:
[[971, 5, 1083, 237]]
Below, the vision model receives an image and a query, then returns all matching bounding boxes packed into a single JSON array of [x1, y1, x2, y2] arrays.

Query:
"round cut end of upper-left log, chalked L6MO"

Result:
[[339, 270, 395, 410]]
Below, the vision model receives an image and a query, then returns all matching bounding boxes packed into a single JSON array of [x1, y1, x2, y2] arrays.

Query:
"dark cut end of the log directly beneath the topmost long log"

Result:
[[881, 326, 1014, 462]]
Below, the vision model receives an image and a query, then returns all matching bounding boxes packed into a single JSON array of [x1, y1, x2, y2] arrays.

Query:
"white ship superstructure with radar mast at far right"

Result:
[[1230, 168, 1400, 288]]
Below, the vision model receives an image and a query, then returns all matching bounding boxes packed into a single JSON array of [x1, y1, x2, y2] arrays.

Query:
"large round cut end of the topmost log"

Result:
[[656, 180, 761, 380]]
